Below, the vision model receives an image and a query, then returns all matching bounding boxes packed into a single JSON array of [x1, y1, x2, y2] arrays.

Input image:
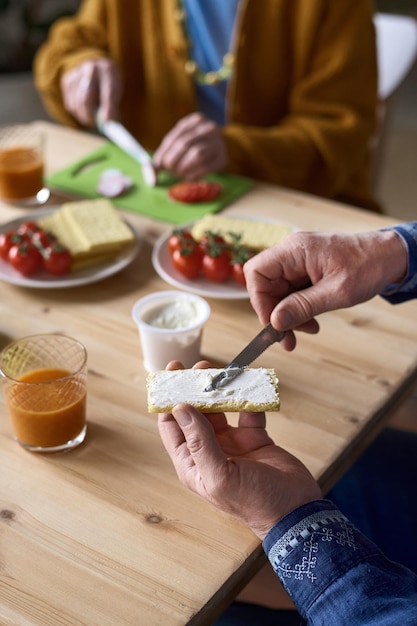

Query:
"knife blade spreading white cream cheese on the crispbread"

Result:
[[204, 324, 286, 391]]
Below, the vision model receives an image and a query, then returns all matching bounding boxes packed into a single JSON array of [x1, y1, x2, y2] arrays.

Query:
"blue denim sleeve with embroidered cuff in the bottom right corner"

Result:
[[263, 500, 417, 626]]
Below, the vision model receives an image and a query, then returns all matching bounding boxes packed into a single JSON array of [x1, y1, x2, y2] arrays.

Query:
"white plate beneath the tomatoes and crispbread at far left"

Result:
[[0, 207, 142, 289]]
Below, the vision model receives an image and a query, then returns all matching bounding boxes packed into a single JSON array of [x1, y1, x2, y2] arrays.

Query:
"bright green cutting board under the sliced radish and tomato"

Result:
[[47, 142, 253, 224]]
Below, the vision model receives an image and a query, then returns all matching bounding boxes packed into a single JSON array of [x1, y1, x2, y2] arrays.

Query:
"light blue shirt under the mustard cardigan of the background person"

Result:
[[184, 0, 239, 126]]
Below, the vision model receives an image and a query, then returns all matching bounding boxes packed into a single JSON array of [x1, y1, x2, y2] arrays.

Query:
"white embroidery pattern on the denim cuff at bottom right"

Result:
[[268, 511, 357, 582]]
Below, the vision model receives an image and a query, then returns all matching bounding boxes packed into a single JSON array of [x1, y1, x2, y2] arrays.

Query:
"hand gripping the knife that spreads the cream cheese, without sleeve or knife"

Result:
[[244, 231, 407, 350]]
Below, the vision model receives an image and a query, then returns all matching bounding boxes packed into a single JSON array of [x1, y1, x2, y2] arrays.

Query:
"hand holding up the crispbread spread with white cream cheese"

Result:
[[158, 361, 322, 540]]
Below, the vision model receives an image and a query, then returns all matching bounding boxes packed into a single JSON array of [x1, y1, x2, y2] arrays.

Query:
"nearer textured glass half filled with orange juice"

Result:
[[0, 334, 87, 452]]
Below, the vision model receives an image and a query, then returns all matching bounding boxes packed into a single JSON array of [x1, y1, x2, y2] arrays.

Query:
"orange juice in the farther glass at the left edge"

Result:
[[0, 146, 43, 200]]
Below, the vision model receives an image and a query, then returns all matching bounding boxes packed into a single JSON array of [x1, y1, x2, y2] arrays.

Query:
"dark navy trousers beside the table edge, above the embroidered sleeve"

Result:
[[326, 424, 417, 573]]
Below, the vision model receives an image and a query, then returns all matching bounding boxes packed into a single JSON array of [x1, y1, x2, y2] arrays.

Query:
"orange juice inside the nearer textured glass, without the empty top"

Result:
[[6, 369, 86, 448]]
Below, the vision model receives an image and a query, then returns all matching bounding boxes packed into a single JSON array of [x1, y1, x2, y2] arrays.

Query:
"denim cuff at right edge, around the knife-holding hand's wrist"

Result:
[[380, 222, 417, 304]]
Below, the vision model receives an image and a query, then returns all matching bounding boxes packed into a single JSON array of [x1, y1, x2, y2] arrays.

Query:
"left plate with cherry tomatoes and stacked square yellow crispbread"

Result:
[[0, 199, 141, 289]]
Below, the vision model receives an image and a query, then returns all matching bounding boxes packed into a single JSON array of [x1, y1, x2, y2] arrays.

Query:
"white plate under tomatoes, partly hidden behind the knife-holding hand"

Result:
[[152, 215, 297, 300]]
